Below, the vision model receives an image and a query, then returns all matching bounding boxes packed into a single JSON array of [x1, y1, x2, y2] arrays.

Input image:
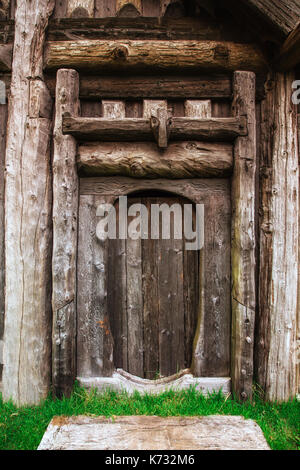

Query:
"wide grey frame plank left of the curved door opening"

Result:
[[77, 195, 114, 377]]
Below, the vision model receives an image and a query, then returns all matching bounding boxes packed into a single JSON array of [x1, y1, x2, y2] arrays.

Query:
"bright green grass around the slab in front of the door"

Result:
[[0, 386, 300, 450]]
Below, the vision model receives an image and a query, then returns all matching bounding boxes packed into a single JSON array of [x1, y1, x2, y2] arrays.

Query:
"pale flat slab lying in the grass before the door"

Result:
[[39, 415, 269, 450]]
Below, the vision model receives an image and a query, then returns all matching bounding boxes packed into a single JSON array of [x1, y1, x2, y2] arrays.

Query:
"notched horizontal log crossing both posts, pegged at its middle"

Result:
[[63, 115, 247, 142]]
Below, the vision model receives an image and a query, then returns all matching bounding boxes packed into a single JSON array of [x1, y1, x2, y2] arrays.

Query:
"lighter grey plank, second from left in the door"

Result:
[[126, 197, 144, 377]]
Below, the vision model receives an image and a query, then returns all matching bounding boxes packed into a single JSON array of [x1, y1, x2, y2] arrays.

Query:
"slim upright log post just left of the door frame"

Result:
[[52, 69, 80, 396]]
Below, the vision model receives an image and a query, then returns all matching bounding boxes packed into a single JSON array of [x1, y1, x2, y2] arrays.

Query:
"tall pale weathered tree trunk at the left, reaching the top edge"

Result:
[[3, 0, 54, 405]]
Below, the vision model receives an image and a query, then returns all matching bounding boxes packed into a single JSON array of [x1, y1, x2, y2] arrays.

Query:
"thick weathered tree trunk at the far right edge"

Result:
[[256, 73, 299, 400]]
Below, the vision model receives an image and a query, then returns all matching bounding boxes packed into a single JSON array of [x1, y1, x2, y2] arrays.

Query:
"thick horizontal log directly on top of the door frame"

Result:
[[77, 141, 233, 178]]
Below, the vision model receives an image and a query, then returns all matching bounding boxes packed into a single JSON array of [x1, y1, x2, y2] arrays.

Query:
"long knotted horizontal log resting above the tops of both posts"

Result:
[[45, 40, 266, 72]]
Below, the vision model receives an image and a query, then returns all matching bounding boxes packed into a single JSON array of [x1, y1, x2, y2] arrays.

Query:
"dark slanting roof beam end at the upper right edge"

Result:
[[275, 23, 300, 71]]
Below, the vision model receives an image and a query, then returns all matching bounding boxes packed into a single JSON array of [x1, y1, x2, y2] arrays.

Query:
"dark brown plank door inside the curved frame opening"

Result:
[[107, 193, 199, 379]]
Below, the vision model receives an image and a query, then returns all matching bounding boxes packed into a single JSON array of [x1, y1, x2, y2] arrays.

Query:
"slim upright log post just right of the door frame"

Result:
[[231, 72, 256, 400]]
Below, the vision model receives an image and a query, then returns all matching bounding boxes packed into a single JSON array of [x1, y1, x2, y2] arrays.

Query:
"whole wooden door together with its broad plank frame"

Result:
[[77, 177, 231, 379]]
